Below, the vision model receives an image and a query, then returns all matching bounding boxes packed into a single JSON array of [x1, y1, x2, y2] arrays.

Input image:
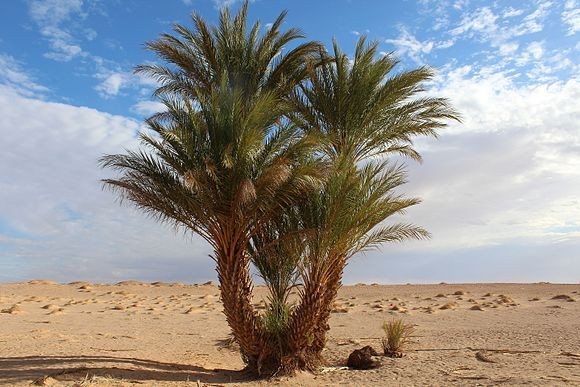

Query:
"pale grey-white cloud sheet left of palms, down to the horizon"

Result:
[[0, 89, 213, 281]]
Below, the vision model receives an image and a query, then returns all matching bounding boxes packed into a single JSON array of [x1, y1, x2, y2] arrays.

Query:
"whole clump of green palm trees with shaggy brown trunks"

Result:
[[101, 2, 457, 374]]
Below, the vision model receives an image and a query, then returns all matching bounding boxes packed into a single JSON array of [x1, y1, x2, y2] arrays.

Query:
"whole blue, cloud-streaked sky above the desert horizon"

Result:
[[0, 0, 580, 283]]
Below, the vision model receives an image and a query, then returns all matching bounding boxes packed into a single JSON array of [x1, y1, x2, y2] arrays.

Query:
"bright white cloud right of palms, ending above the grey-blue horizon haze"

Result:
[[405, 66, 580, 250]]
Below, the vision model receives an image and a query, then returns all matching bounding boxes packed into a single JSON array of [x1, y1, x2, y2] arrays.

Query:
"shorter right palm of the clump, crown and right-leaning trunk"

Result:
[[288, 38, 459, 368]]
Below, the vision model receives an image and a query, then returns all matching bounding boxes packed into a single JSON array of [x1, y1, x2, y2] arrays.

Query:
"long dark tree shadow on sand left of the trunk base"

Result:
[[0, 355, 256, 384]]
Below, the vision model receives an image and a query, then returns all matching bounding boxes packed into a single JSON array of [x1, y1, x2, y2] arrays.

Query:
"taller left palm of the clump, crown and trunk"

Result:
[[101, 2, 321, 372]]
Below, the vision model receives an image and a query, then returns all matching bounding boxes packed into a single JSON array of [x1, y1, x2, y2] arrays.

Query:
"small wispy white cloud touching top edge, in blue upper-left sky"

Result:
[[29, 0, 87, 62]]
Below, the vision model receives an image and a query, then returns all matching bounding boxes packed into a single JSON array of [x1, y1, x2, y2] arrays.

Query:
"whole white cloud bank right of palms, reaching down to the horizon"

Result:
[[346, 66, 580, 282]]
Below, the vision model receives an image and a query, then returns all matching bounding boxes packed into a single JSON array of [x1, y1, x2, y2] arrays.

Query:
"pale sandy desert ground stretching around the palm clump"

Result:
[[0, 281, 580, 386]]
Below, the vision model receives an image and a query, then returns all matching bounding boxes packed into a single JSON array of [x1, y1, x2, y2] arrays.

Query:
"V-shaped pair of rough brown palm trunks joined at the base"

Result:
[[215, 223, 345, 375]]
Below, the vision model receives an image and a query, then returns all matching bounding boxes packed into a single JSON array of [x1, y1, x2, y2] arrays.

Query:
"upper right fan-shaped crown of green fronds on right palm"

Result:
[[292, 38, 459, 161]]
